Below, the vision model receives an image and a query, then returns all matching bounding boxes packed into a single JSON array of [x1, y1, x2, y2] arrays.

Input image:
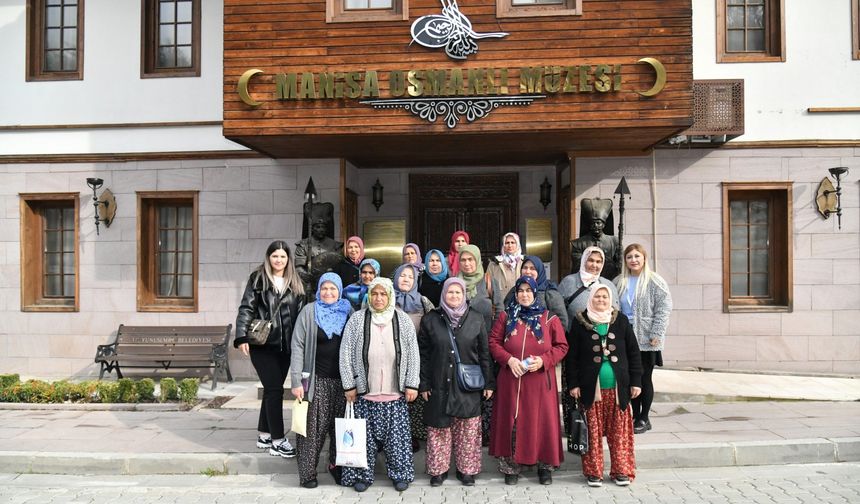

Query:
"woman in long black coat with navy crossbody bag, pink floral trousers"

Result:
[[418, 278, 495, 486]]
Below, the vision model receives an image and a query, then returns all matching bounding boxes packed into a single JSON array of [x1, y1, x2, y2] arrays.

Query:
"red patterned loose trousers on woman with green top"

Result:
[[582, 389, 636, 481]]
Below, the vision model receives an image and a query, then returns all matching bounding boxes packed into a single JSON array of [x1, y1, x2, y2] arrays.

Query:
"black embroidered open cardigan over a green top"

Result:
[[565, 310, 642, 410]]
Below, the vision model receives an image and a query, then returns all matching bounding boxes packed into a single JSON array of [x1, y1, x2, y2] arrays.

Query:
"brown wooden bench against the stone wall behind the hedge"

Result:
[[95, 324, 233, 390]]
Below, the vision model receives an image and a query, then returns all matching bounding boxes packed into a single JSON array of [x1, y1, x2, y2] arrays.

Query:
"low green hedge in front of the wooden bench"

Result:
[[0, 374, 200, 404]]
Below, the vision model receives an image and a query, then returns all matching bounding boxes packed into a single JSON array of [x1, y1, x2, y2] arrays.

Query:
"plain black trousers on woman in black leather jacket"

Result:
[[251, 345, 290, 439]]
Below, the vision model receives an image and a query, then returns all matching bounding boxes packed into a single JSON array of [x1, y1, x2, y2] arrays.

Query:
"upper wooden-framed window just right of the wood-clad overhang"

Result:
[[717, 0, 785, 63]]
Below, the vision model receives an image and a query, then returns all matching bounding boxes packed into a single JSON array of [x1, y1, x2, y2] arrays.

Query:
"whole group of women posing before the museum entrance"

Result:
[[234, 231, 671, 492]]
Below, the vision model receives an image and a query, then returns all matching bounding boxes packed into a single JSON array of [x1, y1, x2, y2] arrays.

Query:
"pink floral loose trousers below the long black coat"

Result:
[[427, 416, 481, 476]]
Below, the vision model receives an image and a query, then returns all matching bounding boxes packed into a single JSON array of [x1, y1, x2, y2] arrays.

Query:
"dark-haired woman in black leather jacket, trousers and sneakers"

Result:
[[233, 240, 305, 458]]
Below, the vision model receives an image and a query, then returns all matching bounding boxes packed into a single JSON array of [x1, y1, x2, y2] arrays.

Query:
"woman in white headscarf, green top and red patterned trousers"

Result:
[[566, 284, 642, 487]]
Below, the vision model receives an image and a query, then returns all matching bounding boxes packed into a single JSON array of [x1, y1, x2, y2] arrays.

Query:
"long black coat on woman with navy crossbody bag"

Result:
[[418, 308, 496, 428]]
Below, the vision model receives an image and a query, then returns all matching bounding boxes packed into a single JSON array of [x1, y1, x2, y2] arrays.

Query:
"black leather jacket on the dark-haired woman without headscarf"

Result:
[[233, 271, 305, 353]]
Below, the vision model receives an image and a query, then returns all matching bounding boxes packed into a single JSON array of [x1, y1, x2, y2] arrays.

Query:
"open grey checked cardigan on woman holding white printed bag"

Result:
[[340, 308, 421, 395]]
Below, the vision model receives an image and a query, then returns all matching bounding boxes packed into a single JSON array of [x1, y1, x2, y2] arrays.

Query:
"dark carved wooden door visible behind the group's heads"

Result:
[[409, 173, 522, 265]]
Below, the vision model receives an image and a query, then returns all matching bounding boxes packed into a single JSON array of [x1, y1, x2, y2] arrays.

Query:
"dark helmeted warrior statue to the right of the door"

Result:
[[570, 198, 621, 280]]
